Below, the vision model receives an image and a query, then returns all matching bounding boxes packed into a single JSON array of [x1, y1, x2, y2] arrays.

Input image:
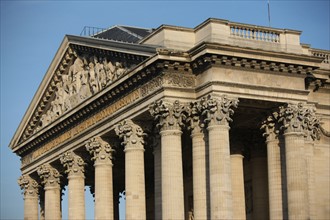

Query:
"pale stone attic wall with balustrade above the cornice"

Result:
[[141, 19, 307, 54]]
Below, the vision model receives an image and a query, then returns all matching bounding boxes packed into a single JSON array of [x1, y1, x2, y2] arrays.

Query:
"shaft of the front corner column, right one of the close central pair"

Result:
[[208, 125, 233, 219]]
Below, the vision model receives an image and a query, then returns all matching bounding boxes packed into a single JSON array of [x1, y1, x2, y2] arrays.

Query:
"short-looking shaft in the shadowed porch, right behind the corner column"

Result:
[[230, 154, 246, 220]]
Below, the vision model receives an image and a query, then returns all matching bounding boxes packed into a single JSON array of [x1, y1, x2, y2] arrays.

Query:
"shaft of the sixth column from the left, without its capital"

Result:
[[160, 130, 184, 220]]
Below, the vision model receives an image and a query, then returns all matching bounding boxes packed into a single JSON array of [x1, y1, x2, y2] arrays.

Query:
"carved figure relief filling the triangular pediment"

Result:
[[34, 54, 129, 133]]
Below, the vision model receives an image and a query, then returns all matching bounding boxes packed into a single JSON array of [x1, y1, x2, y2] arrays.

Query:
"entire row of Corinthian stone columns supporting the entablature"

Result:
[[19, 96, 318, 220]]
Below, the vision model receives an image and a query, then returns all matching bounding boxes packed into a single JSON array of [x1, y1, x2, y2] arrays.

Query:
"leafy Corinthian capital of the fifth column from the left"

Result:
[[115, 119, 146, 149]]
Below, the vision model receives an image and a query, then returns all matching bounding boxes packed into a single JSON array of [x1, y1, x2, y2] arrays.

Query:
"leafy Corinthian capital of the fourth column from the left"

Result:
[[85, 136, 113, 162]]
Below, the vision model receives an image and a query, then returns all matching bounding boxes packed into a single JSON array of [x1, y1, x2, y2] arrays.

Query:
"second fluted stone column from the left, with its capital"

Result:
[[37, 164, 62, 220]]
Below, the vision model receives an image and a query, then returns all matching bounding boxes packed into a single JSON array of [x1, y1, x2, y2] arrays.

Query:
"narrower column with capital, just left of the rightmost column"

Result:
[[261, 113, 284, 220]]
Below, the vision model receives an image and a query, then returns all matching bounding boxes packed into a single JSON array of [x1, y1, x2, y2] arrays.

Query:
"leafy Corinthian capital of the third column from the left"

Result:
[[60, 151, 85, 176]]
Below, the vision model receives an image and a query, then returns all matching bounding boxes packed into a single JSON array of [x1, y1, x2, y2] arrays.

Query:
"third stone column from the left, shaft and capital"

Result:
[[60, 151, 85, 220]]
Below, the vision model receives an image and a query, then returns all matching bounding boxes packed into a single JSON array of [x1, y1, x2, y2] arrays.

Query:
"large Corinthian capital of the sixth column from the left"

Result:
[[149, 100, 186, 130]]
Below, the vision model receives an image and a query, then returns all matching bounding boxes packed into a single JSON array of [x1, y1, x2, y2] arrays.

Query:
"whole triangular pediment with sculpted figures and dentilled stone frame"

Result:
[[10, 36, 155, 151]]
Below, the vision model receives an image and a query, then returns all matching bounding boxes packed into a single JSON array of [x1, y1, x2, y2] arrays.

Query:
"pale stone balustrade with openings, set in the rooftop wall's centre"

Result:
[[230, 25, 280, 43]]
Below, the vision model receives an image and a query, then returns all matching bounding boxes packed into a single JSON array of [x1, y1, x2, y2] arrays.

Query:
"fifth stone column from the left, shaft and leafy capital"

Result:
[[115, 120, 146, 220]]
